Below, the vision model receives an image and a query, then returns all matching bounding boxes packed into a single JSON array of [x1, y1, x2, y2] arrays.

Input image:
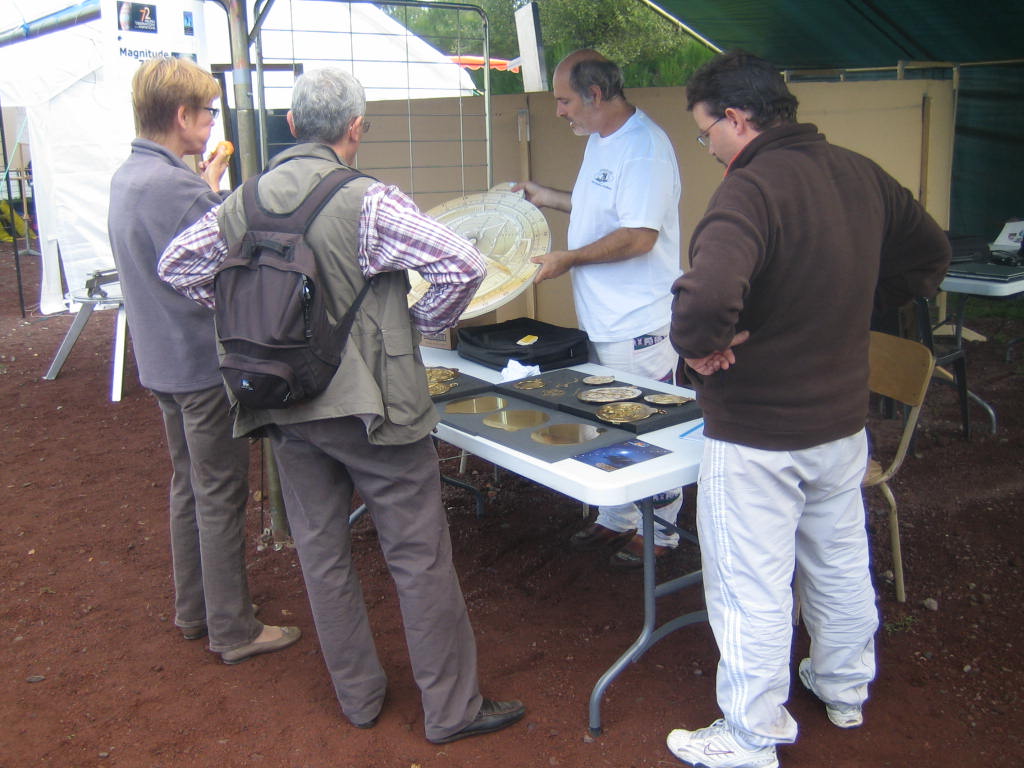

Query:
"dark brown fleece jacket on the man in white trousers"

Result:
[[672, 124, 950, 451]]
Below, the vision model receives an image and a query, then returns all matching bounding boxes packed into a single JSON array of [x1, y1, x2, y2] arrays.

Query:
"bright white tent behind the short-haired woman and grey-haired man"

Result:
[[0, 0, 472, 313]]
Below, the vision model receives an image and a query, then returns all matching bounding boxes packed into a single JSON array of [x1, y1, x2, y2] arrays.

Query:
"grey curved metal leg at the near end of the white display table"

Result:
[[590, 498, 708, 736]]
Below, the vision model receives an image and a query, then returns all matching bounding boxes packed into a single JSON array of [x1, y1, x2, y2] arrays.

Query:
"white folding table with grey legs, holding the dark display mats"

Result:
[[420, 347, 708, 735]]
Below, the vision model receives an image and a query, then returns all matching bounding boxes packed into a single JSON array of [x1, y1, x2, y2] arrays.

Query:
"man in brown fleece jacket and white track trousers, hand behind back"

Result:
[[668, 52, 950, 768]]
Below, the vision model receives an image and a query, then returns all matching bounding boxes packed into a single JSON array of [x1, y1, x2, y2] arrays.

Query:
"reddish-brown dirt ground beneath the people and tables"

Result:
[[0, 247, 1024, 768]]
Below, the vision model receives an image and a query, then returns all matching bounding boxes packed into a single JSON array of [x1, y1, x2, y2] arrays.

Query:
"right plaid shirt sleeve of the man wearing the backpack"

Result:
[[359, 182, 487, 333]]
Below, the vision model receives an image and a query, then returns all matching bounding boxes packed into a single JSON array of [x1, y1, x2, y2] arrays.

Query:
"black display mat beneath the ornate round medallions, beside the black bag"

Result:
[[495, 368, 701, 436]]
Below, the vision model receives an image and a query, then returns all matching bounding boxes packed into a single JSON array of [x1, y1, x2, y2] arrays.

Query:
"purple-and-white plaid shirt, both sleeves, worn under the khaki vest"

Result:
[[157, 181, 486, 333]]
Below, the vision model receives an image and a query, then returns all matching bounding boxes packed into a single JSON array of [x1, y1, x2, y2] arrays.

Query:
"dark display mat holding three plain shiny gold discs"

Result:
[[434, 391, 633, 463]]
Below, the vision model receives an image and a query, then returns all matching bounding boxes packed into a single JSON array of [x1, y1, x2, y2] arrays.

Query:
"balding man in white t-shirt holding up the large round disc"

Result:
[[513, 50, 682, 568]]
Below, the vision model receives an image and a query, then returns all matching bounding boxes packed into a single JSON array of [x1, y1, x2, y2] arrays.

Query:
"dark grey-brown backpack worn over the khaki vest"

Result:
[[214, 168, 370, 410]]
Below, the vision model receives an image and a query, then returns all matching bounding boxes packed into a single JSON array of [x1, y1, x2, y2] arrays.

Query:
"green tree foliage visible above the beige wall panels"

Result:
[[381, 0, 713, 93]]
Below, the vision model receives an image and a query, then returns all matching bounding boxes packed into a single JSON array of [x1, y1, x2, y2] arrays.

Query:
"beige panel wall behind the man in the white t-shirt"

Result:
[[359, 80, 953, 327]]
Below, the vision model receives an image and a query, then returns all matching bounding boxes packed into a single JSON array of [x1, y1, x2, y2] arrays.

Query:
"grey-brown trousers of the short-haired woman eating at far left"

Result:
[[154, 387, 263, 653]]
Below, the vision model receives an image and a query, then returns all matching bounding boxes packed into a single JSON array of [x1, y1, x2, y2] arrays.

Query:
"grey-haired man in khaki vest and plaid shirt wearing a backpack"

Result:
[[159, 69, 525, 743]]
